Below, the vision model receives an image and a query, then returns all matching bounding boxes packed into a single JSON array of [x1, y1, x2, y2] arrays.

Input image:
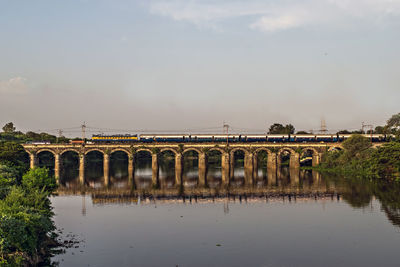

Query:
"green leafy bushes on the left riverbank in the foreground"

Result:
[[0, 168, 57, 266]]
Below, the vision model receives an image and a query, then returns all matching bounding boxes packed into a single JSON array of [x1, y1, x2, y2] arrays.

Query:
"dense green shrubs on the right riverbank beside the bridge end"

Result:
[[317, 135, 400, 181]]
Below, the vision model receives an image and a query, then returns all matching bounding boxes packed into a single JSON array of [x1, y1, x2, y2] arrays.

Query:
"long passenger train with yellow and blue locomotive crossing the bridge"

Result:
[[89, 134, 394, 143]]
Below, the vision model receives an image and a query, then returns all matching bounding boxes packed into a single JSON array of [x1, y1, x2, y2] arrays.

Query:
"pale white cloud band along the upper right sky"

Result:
[[149, 0, 400, 32]]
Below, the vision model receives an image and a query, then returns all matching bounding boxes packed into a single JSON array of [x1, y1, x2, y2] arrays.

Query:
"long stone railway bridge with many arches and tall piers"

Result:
[[23, 143, 341, 185]]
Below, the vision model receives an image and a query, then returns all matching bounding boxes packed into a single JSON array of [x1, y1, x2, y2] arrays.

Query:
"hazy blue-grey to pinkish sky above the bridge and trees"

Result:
[[0, 0, 400, 134]]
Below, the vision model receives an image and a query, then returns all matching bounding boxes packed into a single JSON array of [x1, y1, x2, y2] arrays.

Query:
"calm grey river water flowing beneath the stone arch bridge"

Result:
[[51, 155, 400, 266]]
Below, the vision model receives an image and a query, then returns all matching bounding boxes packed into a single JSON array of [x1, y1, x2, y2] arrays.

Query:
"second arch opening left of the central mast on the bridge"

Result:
[[182, 150, 199, 187]]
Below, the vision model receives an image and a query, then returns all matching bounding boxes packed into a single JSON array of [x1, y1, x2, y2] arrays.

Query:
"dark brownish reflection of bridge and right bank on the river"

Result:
[[58, 159, 400, 232]]
